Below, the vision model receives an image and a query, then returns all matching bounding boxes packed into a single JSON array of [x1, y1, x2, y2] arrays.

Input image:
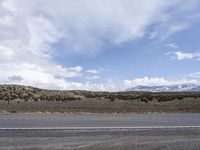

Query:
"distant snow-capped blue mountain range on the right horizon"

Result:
[[126, 84, 200, 92]]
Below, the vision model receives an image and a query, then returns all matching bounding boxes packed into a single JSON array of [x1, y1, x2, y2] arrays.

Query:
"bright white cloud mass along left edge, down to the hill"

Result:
[[0, 1, 82, 88]]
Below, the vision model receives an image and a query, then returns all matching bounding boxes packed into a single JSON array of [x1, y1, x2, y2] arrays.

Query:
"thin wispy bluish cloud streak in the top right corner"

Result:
[[149, 0, 200, 40]]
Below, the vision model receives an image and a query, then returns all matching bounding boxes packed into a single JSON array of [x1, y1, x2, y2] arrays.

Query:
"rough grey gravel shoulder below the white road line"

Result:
[[0, 128, 200, 150]]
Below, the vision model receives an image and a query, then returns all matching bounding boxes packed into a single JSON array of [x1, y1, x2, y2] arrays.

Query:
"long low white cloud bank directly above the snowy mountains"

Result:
[[123, 77, 200, 88]]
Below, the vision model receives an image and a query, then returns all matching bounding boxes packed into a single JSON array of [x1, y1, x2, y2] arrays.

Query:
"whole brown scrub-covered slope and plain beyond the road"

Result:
[[0, 85, 200, 113]]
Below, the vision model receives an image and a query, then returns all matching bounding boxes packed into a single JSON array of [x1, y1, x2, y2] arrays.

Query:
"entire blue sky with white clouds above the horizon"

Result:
[[0, 0, 200, 91]]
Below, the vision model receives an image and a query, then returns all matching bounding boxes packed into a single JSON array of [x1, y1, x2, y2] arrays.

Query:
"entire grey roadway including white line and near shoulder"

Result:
[[0, 114, 200, 150]]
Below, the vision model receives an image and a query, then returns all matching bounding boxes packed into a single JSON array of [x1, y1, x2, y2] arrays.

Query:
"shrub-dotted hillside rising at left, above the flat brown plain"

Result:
[[0, 85, 81, 101]]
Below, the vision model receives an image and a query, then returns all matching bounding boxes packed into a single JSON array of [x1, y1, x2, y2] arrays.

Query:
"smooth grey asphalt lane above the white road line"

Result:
[[0, 113, 200, 129]]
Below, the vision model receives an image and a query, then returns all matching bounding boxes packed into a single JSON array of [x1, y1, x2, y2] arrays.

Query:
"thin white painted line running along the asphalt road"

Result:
[[0, 126, 200, 130]]
